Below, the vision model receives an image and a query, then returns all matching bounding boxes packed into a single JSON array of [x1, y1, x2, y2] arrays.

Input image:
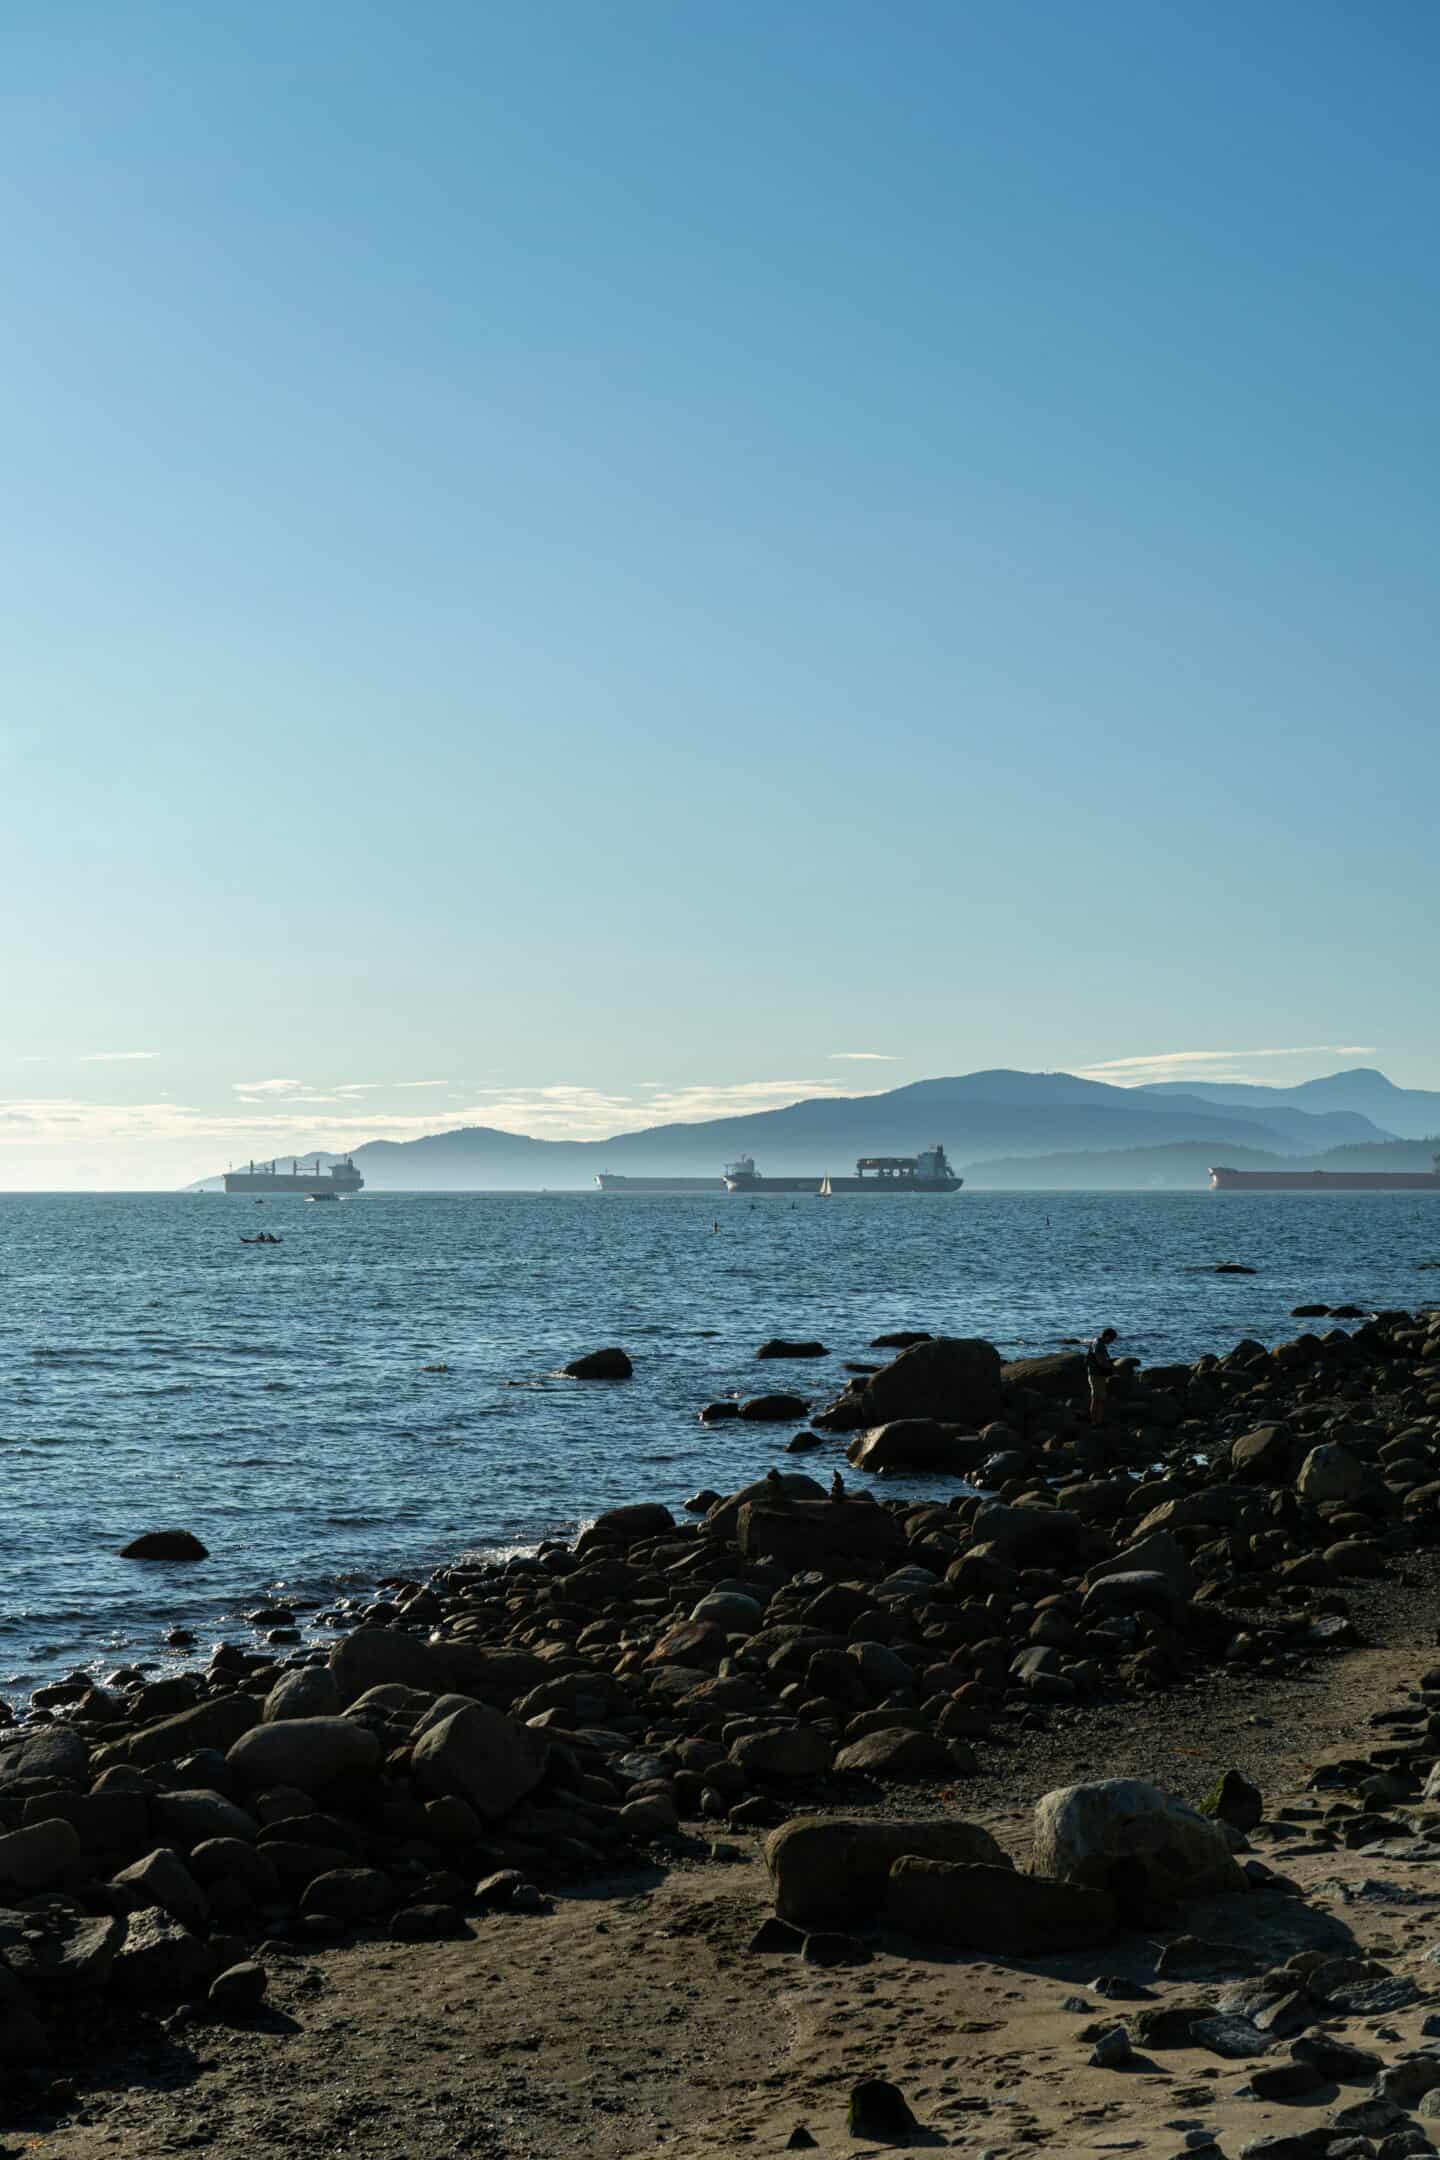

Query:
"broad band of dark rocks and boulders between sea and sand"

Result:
[[0, 1313, 1440, 2160]]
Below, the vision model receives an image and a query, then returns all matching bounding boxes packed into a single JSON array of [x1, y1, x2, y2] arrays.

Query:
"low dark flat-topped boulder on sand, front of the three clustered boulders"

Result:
[[885, 1855, 1116, 1957]]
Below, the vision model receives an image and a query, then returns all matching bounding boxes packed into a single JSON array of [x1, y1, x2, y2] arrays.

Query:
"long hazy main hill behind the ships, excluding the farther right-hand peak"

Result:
[[185, 1069, 1416, 1192]]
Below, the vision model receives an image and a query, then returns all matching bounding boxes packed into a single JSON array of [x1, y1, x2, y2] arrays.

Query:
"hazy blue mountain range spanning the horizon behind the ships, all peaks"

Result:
[[194, 1067, 1440, 1192]]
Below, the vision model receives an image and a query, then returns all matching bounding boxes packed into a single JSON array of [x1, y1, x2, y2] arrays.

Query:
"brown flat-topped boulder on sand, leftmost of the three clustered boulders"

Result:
[[764, 1814, 1010, 1929]]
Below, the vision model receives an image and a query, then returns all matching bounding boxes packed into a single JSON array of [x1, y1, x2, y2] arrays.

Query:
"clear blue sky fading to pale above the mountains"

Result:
[[0, 0, 1440, 1186]]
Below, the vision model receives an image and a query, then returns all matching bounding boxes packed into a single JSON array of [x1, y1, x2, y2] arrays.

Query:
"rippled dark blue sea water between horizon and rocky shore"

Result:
[[0, 1192, 1440, 1698]]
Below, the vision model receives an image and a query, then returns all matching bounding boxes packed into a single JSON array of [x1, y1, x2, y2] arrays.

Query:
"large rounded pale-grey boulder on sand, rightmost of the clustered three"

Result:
[[1032, 1778, 1246, 1918]]
